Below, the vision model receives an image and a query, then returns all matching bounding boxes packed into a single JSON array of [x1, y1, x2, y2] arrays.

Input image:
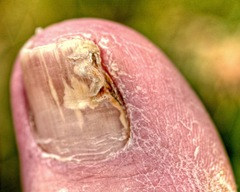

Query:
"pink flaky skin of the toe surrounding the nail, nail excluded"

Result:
[[11, 19, 236, 192]]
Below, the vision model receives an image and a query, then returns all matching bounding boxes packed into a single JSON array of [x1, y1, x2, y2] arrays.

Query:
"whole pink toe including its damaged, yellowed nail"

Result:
[[11, 19, 236, 192]]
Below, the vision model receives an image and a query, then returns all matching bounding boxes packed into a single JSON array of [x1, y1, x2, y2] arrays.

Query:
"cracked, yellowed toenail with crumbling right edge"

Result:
[[20, 36, 130, 161]]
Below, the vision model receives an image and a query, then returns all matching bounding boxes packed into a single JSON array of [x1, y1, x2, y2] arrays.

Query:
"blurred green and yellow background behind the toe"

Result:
[[0, 0, 240, 192]]
